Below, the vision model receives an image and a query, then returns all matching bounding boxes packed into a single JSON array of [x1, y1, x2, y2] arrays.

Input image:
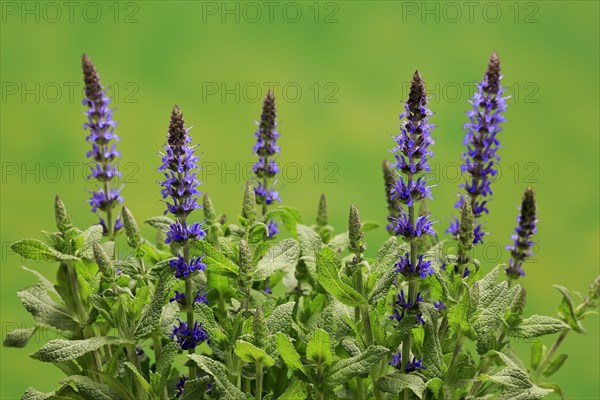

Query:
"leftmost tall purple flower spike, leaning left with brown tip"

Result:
[[82, 54, 123, 236]]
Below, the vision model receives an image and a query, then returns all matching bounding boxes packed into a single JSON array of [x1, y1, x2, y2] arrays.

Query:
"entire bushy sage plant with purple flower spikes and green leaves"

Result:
[[4, 53, 600, 400]]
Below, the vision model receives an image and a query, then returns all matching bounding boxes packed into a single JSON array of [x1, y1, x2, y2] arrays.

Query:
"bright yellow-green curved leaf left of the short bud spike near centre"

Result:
[[317, 247, 367, 307]]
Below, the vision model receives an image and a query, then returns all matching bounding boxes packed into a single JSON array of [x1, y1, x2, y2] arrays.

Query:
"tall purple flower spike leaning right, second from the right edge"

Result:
[[446, 52, 506, 244]]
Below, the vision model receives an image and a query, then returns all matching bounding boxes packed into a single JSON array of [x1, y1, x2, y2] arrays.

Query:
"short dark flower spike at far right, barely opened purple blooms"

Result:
[[505, 188, 537, 279]]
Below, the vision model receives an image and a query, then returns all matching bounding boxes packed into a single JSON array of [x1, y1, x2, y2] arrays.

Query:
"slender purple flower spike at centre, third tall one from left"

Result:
[[252, 90, 281, 228]]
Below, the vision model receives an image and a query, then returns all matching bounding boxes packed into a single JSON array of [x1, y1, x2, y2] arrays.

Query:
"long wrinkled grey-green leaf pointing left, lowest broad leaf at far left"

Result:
[[31, 336, 126, 362]]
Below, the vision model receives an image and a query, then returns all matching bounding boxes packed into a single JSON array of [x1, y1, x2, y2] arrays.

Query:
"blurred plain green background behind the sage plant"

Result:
[[0, 1, 600, 399]]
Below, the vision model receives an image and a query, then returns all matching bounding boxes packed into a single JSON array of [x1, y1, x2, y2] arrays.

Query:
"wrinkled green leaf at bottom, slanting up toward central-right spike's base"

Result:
[[325, 346, 390, 388]]
